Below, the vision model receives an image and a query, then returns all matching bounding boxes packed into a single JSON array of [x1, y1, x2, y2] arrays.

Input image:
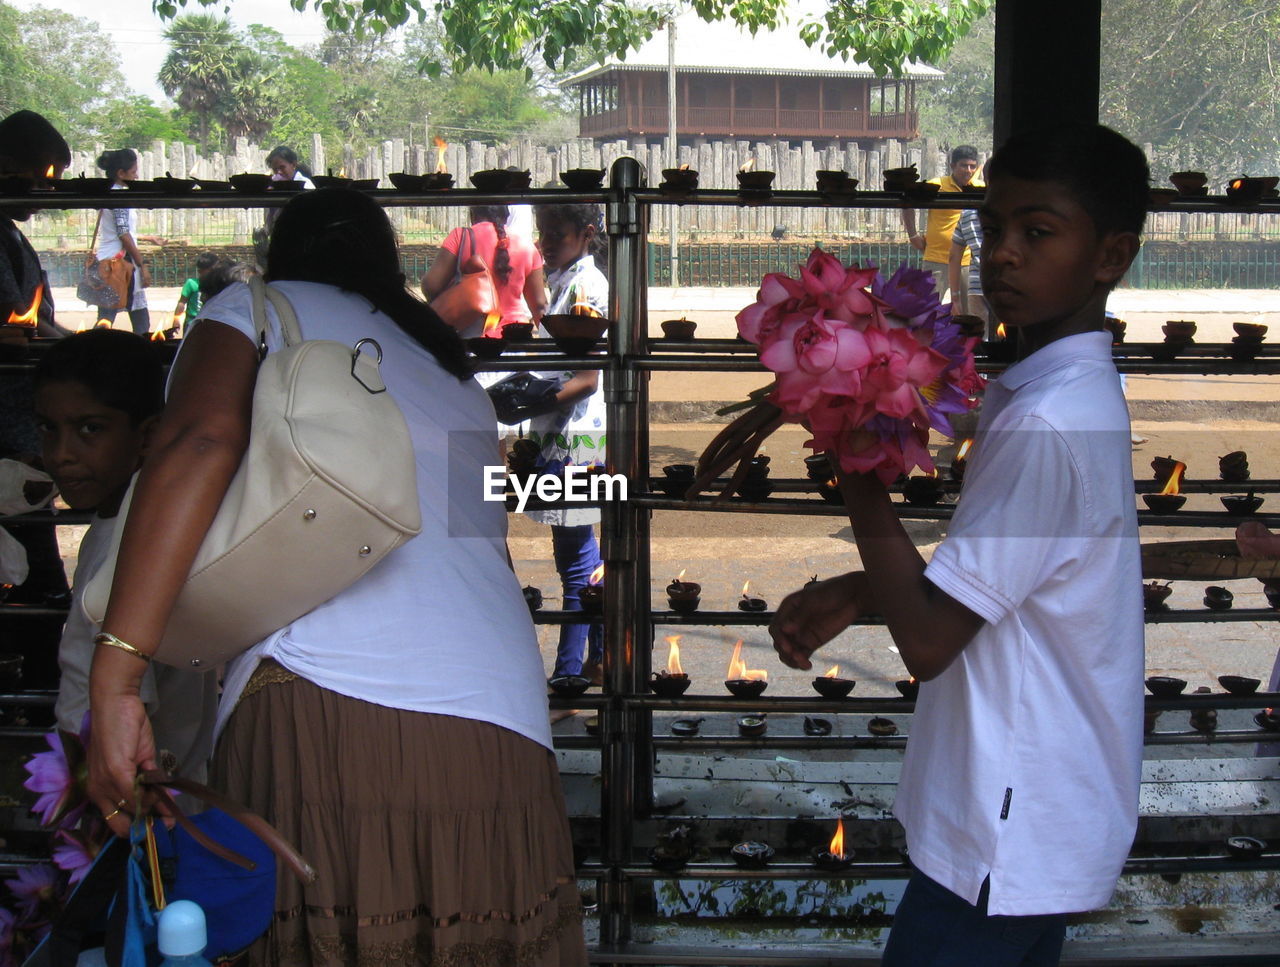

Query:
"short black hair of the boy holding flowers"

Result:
[[987, 124, 1151, 236]]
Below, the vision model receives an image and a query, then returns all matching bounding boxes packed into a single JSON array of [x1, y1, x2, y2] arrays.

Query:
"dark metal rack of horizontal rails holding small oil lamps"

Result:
[[0, 158, 1280, 967]]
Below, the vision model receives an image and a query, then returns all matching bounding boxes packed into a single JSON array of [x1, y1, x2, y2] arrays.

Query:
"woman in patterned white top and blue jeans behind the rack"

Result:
[[529, 205, 609, 685]]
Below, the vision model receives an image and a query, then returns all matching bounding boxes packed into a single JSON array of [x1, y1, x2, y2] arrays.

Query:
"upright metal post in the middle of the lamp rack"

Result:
[[600, 158, 650, 945]]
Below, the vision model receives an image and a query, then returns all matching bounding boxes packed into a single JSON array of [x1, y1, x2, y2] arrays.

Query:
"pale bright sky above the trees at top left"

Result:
[[9, 0, 324, 104]]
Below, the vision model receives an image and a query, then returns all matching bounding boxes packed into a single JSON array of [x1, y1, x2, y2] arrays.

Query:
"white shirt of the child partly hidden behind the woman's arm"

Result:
[[54, 516, 218, 783]]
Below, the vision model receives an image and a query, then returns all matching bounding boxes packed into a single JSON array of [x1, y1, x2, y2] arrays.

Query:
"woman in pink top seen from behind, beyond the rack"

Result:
[[422, 205, 547, 337]]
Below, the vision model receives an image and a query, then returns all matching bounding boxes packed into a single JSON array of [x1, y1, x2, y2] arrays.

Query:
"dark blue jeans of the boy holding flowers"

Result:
[[881, 871, 1066, 967]]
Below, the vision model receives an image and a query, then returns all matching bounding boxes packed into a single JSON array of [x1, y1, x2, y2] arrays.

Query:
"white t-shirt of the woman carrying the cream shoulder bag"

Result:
[[195, 282, 552, 748]]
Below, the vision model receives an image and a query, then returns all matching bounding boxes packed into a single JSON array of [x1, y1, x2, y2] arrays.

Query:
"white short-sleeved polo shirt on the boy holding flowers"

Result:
[[895, 333, 1143, 916]]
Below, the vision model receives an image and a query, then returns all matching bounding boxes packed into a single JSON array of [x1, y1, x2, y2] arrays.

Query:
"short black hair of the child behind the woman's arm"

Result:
[[32, 329, 164, 427]]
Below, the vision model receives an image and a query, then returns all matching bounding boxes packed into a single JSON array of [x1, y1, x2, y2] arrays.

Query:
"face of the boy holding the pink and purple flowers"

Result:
[[979, 175, 1138, 338]]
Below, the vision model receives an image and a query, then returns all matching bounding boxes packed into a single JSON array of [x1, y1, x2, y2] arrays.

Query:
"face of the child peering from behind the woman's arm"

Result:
[[36, 380, 154, 517]]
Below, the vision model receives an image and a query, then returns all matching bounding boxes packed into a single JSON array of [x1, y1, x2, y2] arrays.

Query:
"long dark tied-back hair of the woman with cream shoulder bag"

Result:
[[265, 188, 472, 379]]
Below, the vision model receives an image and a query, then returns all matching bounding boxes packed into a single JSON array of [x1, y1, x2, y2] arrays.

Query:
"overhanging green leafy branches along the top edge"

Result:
[[151, 0, 995, 77]]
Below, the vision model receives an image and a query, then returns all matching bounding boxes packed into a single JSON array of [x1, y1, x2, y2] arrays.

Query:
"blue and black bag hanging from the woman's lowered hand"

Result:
[[24, 771, 316, 967]]
